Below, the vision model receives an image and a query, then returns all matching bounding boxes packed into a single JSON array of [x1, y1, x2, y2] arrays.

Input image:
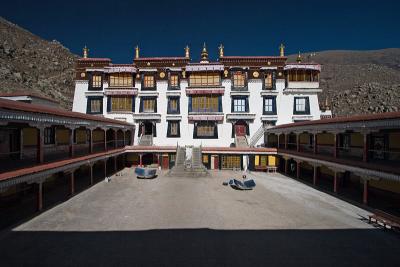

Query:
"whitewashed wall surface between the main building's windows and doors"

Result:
[[72, 71, 321, 147]]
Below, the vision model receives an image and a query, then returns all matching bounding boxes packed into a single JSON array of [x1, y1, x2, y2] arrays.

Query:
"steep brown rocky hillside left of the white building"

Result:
[[0, 17, 76, 109]]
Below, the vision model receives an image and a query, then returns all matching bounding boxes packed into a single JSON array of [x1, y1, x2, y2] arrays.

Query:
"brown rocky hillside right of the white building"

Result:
[[289, 48, 400, 116]]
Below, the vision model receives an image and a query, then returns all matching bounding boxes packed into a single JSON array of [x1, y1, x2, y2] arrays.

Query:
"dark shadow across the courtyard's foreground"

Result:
[[0, 229, 400, 267]]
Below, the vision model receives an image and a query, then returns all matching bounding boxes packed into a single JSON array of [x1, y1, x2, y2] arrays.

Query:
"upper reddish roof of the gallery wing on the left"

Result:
[[0, 99, 133, 126]]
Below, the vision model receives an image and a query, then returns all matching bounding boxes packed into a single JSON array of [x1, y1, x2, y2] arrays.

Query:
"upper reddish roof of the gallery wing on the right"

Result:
[[272, 112, 400, 129]]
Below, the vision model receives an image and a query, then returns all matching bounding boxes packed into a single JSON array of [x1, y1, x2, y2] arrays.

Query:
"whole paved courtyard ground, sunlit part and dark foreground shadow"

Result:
[[0, 169, 400, 266]]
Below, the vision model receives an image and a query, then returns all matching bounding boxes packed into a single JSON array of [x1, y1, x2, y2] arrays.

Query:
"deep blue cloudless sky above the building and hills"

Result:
[[0, 0, 400, 63]]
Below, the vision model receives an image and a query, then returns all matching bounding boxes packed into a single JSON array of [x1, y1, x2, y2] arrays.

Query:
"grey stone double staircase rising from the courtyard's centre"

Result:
[[167, 147, 209, 177]]
